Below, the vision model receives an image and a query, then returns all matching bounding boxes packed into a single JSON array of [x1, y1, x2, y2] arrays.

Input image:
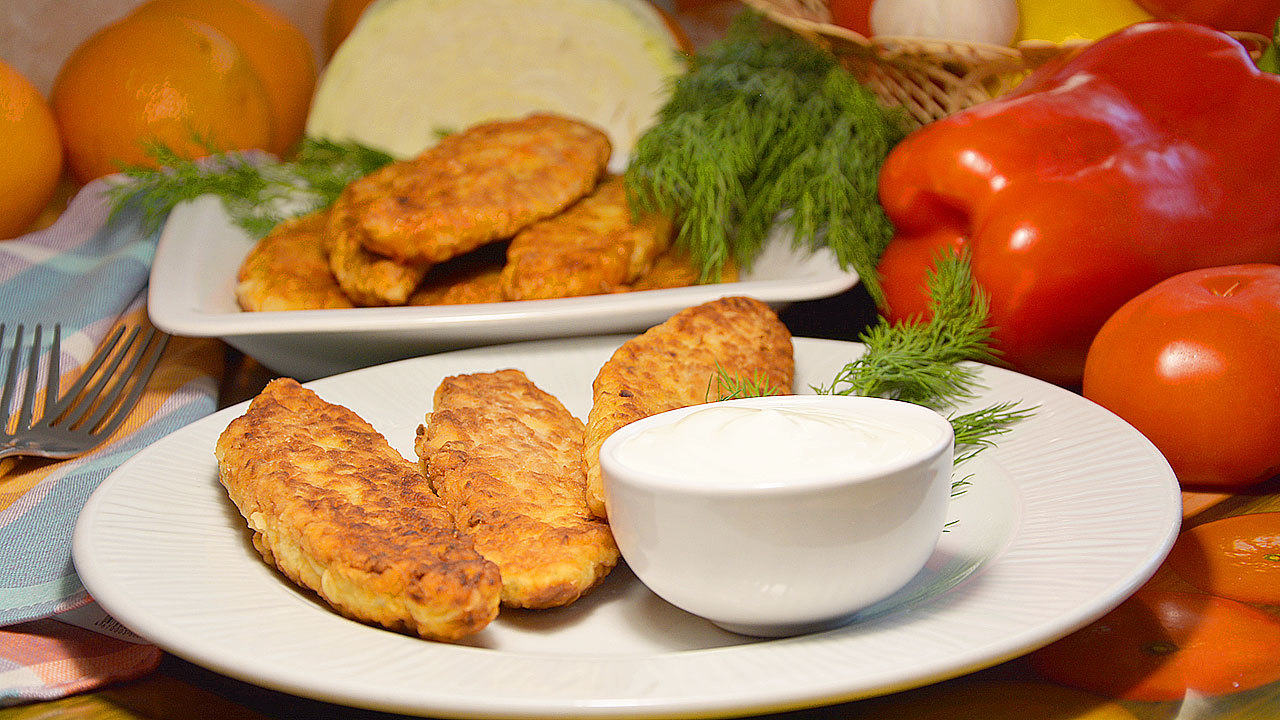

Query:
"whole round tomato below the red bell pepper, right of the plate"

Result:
[[1083, 264, 1280, 488]]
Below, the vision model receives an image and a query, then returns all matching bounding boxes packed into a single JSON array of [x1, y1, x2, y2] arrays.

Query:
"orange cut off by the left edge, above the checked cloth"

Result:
[[0, 60, 63, 238]]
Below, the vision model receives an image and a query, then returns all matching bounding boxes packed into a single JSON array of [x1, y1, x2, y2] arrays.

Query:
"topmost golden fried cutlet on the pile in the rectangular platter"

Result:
[[347, 115, 612, 264]]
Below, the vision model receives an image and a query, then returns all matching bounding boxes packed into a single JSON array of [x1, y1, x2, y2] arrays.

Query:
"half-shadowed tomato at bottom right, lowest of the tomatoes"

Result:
[[1029, 589, 1280, 702]]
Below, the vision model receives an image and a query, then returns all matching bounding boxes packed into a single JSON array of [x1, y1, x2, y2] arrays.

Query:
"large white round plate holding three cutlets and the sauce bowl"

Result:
[[73, 336, 1180, 717]]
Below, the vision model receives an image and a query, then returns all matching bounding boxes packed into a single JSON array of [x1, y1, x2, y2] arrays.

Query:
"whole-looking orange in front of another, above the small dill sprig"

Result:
[[52, 13, 271, 182]]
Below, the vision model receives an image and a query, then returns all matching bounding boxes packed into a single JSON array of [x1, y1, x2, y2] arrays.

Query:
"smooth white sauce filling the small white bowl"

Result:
[[617, 404, 942, 486]]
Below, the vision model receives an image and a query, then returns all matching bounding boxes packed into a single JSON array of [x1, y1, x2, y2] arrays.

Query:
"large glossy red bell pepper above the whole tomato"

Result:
[[878, 22, 1280, 386]]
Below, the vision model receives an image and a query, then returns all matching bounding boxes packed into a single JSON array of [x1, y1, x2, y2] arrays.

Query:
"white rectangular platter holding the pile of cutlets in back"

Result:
[[147, 196, 858, 380]]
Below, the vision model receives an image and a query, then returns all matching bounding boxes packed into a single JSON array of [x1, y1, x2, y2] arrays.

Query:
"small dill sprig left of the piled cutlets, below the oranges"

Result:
[[108, 138, 392, 237]]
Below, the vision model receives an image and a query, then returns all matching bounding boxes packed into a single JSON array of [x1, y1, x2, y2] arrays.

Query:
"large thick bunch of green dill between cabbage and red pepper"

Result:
[[626, 10, 904, 299]]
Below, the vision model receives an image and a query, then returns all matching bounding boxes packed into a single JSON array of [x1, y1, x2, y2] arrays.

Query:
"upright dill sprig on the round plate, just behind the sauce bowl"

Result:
[[819, 255, 996, 409]]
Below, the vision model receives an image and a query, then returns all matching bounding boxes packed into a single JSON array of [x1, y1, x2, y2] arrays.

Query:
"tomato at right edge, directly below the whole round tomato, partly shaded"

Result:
[[1165, 512, 1280, 605]]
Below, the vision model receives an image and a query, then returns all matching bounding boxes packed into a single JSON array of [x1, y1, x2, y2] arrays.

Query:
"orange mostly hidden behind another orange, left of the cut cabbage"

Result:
[[134, 0, 316, 155]]
